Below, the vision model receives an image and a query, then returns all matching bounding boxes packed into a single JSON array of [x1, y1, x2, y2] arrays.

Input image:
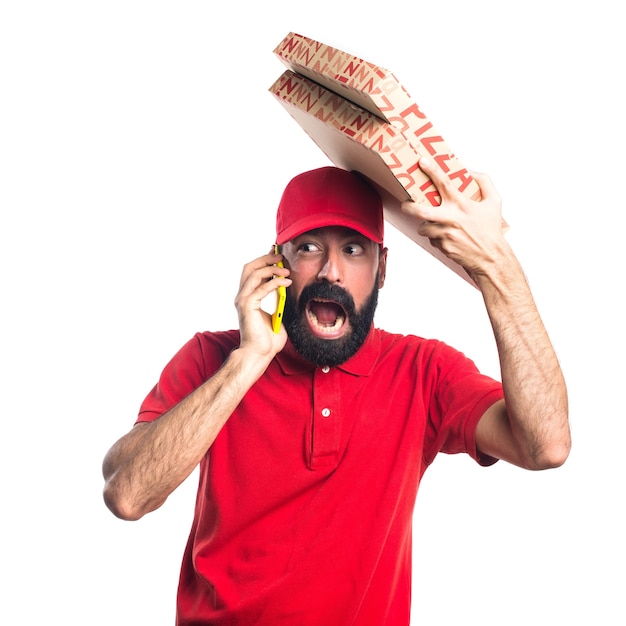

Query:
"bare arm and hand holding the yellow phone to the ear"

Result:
[[102, 249, 291, 520]]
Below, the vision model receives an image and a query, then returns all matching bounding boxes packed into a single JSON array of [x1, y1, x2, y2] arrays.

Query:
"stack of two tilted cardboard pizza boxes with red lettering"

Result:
[[269, 33, 480, 283]]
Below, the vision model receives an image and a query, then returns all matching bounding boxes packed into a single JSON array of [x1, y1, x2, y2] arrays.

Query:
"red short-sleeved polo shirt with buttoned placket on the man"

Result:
[[138, 329, 502, 626]]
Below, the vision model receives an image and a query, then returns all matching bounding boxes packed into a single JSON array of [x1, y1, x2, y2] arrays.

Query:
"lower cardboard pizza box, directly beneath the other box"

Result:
[[269, 70, 474, 284]]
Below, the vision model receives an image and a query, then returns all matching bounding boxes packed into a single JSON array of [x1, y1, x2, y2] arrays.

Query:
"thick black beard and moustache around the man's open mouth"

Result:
[[283, 279, 379, 367]]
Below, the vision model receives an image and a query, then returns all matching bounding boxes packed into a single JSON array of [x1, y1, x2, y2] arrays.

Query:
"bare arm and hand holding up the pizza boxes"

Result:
[[402, 159, 571, 470]]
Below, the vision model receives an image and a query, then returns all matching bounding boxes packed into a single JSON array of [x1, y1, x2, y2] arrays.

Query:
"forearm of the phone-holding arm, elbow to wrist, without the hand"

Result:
[[103, 350, 267, 519]]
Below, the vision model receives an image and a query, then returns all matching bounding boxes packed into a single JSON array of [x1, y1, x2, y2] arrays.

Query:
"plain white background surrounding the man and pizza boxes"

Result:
[[0, 0, 626, 626]]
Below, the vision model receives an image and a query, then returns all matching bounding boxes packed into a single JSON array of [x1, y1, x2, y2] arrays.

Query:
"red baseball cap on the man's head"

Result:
[[276, 166, 384, 245]]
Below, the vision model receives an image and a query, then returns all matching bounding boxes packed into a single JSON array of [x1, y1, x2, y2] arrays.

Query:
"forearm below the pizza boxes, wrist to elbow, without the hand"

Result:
[[474, 241, 571, 469]]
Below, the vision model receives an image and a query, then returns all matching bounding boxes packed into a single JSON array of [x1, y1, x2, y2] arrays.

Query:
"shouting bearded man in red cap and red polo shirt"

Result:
[[103, 159, 570, 626]]
